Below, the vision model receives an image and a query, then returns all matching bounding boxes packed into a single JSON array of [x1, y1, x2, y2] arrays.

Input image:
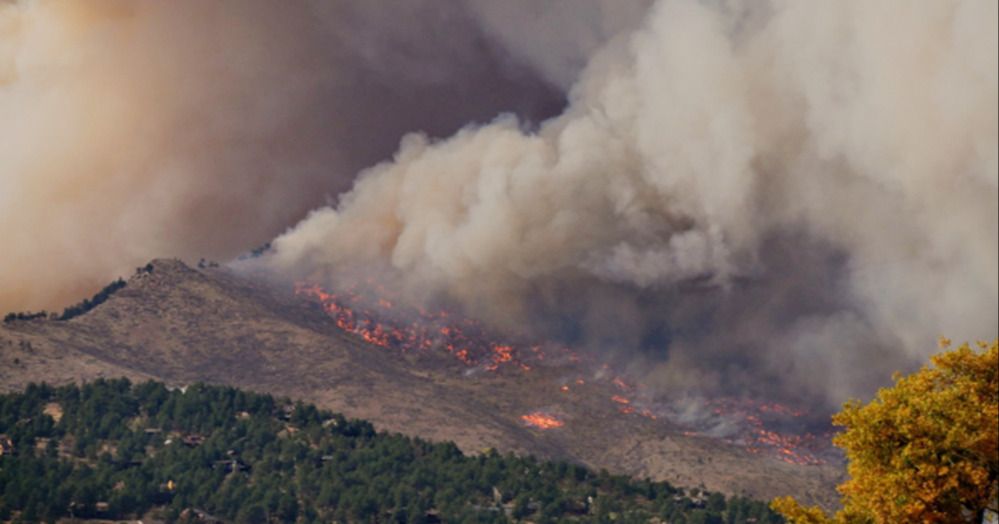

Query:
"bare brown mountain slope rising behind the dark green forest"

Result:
[[0, 260, 842, 506]]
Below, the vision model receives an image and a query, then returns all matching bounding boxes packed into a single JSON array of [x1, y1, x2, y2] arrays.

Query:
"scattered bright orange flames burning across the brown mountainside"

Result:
[[295, 282, 824, 464]]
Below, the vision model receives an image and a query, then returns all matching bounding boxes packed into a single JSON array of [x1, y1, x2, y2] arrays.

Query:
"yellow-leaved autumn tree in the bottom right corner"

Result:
[[771, 339, 999, 524]]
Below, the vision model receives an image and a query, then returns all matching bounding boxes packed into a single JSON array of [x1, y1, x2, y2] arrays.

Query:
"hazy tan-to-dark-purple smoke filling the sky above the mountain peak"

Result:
[[0, 0, 641, 311]]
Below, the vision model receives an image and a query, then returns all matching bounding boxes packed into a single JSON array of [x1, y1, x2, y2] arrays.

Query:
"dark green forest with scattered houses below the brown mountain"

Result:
[[0, 379, 783, 524]]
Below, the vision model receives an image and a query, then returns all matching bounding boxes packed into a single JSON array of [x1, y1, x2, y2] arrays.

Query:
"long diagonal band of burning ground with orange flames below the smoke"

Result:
[[295, 281, 830, 465]]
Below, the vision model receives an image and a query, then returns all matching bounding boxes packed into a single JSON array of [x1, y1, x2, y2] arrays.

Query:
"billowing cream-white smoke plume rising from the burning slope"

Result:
[[270, 0, 999, 404]]
